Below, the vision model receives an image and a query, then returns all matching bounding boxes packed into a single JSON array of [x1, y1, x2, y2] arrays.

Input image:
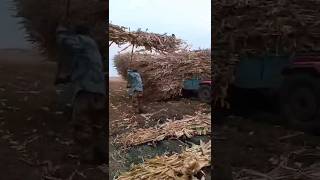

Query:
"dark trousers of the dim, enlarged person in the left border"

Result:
[[72, 92, 108, 159]]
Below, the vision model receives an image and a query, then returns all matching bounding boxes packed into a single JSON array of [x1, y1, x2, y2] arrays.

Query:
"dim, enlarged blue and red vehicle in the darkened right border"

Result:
[[230, 53, 320, 131]]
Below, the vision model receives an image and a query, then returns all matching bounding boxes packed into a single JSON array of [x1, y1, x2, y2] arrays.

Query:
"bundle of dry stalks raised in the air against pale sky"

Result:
[[108, 23, 183, 52]]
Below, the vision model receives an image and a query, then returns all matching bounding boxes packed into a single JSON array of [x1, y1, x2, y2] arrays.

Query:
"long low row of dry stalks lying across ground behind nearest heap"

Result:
[[115, 114, 211, 147]]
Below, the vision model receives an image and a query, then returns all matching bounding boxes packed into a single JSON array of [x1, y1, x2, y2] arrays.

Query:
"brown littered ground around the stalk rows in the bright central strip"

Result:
[[109, 78, 211, 179]]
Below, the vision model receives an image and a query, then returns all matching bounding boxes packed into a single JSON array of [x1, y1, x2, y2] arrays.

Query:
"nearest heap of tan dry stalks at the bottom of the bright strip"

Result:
[[117, 141, 211, 180]]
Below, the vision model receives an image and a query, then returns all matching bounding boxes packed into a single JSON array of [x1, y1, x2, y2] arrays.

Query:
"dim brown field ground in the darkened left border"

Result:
[[0, 49, 107, 180]]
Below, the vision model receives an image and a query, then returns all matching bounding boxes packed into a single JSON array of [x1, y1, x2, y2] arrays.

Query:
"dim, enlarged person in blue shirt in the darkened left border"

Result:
[[55, 25, 108, 164]]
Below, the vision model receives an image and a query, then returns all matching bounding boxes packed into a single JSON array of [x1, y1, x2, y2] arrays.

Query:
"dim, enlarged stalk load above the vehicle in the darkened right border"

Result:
[[213, 0, 320, 107]]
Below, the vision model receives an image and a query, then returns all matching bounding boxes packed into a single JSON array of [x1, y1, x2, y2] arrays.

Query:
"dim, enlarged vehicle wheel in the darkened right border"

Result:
[[280, 74, 320, 130]]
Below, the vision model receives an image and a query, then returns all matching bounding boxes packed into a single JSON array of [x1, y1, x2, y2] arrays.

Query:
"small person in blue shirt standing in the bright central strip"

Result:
[[127, 69, 143, 114]]
